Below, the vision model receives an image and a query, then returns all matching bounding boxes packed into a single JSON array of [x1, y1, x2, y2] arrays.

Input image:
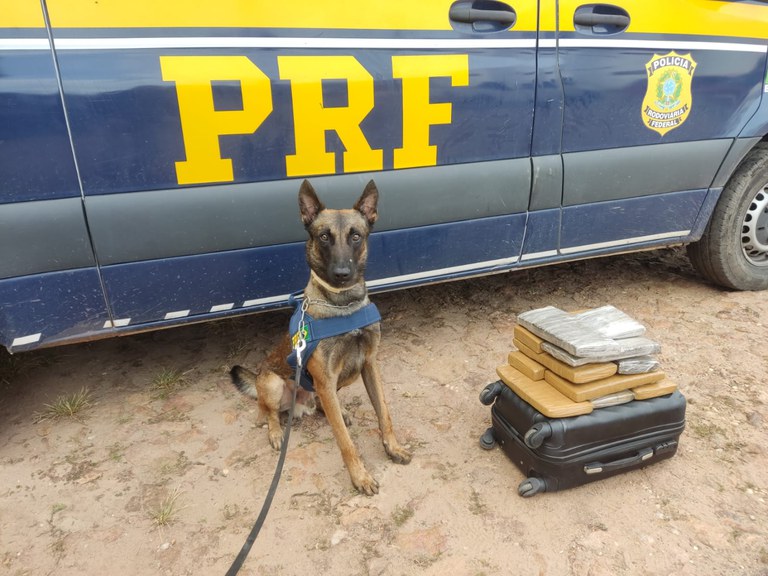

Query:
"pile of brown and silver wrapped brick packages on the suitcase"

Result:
[[497, 306, 677, 418]]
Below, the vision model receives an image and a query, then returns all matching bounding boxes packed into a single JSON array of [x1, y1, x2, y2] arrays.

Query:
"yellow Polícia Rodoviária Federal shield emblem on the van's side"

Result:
[[642, 51, 696, 136]]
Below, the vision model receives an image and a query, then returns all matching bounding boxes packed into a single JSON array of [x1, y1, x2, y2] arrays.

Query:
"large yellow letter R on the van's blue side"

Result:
[[277, 56, 384, 176]]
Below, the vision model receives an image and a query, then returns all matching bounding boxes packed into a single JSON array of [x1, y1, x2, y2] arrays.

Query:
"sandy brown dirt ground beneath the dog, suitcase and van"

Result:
[[0, 245, 768, 576]]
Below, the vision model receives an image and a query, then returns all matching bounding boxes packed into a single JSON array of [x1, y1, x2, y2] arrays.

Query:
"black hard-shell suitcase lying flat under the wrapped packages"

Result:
[[480, 380, 685, 497]]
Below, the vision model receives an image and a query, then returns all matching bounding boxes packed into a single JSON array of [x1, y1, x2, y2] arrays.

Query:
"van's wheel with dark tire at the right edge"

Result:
[[688, 142, 768, 290]]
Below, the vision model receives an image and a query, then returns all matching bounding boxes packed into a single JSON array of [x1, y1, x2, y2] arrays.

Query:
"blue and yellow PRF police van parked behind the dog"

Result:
[[0, 0, 768, 352]]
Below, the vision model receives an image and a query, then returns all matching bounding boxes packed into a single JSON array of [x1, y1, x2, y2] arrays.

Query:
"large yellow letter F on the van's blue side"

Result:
[[392, 54, 469, 168]]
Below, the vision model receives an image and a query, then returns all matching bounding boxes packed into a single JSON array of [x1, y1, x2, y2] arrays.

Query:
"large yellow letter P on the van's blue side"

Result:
[[160, 56, 272, 184]]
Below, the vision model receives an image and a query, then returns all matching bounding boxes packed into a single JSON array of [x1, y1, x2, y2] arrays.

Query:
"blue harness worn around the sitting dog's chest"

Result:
[[287, 295, 381, 392]]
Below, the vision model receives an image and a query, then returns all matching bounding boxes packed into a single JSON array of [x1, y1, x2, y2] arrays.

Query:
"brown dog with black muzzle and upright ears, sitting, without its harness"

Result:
[[231, 180, 411, 496]]
